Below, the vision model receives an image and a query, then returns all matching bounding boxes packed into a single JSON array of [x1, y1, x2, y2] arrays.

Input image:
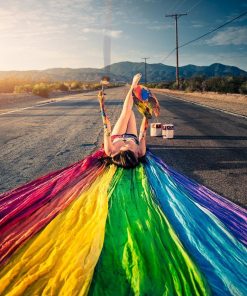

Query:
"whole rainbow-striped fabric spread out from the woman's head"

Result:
[[0, 150, 247, 296]]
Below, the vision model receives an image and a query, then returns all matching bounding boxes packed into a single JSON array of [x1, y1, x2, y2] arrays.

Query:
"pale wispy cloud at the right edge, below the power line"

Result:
[[206, 27, 247, 45]]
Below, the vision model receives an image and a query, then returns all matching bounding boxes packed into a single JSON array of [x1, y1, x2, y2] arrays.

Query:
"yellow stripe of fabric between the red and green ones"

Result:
[[0, 166, 116, 296]]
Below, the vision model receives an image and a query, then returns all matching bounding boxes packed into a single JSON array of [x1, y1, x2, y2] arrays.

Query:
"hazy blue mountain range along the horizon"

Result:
[[0, 62, 247, 82]]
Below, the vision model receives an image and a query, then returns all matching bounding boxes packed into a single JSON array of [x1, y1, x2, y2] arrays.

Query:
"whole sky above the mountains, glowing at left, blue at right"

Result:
[[0, 0, 247, 71]]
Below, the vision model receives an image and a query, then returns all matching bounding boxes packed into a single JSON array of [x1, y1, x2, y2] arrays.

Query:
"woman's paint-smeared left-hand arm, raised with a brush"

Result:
[[98, 91, 112, 156]]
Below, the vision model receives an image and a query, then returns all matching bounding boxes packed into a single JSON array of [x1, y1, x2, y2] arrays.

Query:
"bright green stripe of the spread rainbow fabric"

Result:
[[89, 165, 210, 296]]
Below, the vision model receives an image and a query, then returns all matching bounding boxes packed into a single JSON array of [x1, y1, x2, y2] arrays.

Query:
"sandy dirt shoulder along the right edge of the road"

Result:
[[153, 89, 247, 116]]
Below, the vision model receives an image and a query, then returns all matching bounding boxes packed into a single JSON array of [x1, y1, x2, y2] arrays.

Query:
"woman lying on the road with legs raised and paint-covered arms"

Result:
[[98, 74, 160, 168]]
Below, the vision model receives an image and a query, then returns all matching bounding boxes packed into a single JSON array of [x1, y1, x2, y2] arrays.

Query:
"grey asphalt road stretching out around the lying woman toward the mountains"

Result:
[[0, 87, 247, 206]]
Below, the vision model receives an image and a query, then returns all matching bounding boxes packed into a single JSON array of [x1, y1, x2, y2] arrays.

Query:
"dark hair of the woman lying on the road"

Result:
[[104, 150, 145, 169]]
